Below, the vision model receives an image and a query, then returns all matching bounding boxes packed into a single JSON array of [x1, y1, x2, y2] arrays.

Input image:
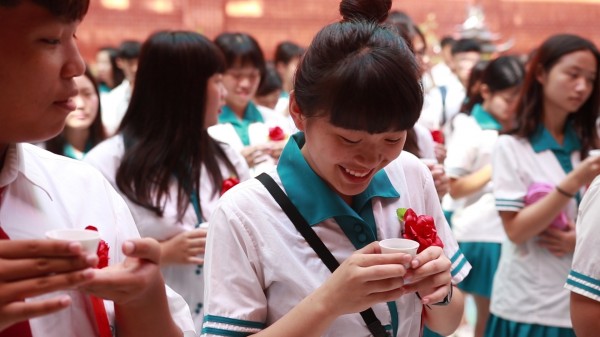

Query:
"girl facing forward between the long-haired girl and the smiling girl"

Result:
[[209, 33, 290, 174]]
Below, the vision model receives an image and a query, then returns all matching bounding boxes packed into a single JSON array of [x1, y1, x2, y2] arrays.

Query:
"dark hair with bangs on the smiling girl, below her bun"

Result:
[[295, 22, 423, 133]]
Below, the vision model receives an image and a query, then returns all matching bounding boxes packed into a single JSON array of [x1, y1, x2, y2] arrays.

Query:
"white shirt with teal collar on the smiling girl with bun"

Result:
[[202, 133, 471, 337]]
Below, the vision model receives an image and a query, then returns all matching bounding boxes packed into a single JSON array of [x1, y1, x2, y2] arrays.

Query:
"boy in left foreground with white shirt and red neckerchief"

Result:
[[0, 0, 194, 337]]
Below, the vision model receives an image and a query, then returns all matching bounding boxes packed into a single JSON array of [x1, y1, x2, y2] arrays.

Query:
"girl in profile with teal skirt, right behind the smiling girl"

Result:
[[445, 56, 525, 337]]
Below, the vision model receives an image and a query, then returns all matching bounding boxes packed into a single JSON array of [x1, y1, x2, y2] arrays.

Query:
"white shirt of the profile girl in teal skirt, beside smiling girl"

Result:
[[444, 104, 506, 243]]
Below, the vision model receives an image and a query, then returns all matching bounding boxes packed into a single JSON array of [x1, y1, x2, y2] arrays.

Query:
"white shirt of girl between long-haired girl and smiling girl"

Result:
[[208, 105, 294, 176]]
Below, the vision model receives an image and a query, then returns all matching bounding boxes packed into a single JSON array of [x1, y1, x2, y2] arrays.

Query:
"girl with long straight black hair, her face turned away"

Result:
[[85, 31, 250, 331]]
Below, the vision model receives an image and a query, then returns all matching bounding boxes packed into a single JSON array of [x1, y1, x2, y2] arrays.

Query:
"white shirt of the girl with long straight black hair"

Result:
[[84, 134, 250, 331]]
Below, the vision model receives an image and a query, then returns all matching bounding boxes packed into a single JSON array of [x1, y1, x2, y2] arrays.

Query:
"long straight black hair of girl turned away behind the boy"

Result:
[[116, 31, 236, 220]]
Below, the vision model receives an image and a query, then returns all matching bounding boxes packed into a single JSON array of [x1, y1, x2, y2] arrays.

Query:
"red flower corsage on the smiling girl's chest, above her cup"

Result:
[[396, 208, 444, 254]]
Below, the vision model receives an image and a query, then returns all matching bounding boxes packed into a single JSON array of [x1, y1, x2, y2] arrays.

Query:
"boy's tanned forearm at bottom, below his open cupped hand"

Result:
[[115, 286, 183, 337]]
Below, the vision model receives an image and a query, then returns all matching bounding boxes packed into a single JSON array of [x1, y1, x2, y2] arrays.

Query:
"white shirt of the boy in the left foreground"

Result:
[[0, 144, 195, 337]]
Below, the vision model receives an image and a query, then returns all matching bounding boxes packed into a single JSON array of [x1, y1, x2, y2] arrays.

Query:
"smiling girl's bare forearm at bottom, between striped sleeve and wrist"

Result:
[[253, 291, 337, 337]]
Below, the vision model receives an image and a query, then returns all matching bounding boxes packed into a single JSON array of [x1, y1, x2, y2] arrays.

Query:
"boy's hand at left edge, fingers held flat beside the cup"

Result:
[[0, 232, 98, 331]]
